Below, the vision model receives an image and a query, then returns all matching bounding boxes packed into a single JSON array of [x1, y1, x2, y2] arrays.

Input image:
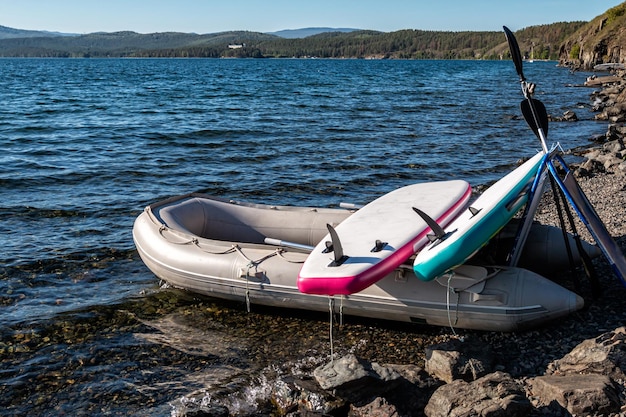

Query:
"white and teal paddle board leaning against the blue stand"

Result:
[[413, 152, 544, 281]]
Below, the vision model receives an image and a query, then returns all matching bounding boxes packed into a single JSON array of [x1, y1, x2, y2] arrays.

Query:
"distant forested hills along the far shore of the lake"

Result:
[[0, 22, 585, 60]]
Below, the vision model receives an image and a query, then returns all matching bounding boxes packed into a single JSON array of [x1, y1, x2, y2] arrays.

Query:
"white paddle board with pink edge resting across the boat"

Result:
[[298, 180, 472, 295]]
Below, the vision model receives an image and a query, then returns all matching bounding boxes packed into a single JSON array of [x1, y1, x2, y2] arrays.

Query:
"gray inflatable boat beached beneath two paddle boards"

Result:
[[133, 194, 583, 331]]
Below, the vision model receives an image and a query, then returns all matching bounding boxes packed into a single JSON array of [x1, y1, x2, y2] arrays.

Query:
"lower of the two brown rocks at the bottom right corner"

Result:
[[529, 375, 620, 415]]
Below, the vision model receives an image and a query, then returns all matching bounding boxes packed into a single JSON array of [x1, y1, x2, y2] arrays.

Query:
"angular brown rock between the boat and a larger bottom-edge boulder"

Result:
[[425, 339, 493, 383]]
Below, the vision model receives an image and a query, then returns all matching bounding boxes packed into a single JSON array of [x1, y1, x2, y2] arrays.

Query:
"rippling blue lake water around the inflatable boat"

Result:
[[0, 59, 606, 415]]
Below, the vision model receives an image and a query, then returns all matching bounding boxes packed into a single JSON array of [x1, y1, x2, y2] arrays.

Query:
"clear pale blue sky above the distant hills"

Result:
[[0, 0, 622, 34]]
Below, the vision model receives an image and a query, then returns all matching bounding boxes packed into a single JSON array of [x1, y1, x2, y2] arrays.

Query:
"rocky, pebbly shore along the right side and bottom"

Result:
[[180, 74, 626, 417]]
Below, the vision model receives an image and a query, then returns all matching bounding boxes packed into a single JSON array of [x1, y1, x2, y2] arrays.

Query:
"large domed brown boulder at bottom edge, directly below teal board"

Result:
[[424, 372, 532, 417]]
